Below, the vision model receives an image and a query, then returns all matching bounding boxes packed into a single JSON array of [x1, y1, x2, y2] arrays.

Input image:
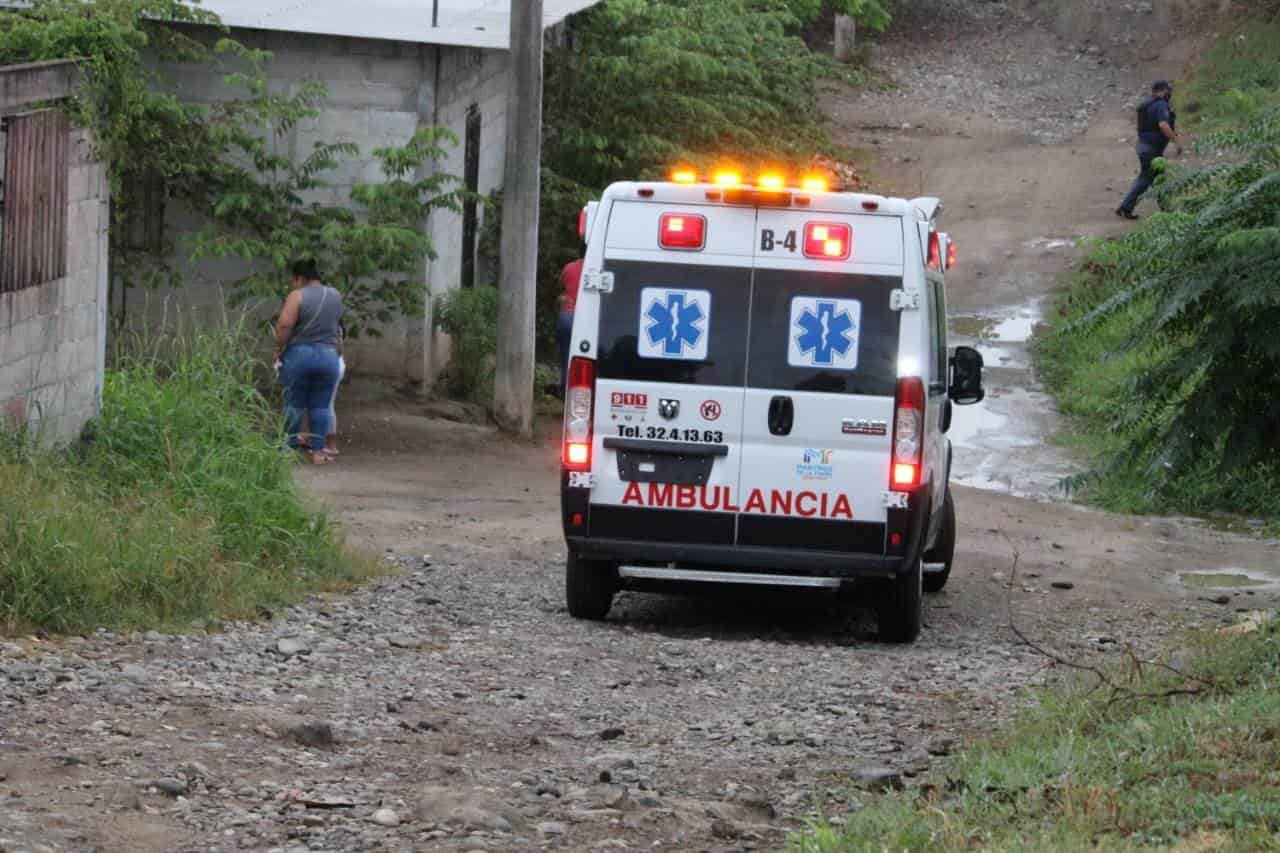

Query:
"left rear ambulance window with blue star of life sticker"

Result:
[[598, 260, 751, 386]]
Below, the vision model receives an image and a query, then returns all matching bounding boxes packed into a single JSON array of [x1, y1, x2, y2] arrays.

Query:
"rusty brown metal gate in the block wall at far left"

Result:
[[0, 110, 69, 293]]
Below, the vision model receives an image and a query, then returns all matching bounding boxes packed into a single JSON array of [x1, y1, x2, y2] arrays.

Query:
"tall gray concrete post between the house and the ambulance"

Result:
[[493, 0, 543, 435]]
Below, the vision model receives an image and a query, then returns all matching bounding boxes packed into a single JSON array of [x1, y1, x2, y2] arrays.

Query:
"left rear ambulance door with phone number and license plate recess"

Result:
[[590, 200, 755, 546]]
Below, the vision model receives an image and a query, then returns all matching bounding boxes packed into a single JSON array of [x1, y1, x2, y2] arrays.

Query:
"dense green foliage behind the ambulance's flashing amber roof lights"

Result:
[[485, 0, 855, 357]]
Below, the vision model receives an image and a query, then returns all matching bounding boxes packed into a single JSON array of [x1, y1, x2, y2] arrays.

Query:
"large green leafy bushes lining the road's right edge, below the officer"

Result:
[[1039, 18, 1280, 519]]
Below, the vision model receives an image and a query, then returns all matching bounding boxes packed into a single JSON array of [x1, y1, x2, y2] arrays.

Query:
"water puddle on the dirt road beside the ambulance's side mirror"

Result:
[[950, 301, 1079, 500]]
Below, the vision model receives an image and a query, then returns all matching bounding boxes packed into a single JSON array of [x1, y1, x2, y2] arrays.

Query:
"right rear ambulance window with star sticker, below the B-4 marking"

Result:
[[746, 269, 902, 397]]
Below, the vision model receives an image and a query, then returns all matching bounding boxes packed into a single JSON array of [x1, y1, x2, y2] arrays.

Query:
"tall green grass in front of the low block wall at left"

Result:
[[0, 317, 374, 633]]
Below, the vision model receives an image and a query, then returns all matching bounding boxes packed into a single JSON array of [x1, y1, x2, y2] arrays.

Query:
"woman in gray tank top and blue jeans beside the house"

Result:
[[275, 260, 343, 465]]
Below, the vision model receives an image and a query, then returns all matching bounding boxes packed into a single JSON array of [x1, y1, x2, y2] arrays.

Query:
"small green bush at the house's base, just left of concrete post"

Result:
[[435, 287, 498, 405]]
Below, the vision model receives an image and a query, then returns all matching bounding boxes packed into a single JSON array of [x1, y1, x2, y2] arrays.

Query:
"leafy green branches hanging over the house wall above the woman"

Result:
[[0, 0, 462, 337]]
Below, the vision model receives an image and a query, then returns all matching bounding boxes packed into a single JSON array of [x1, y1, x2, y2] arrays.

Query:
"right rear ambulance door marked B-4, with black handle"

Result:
[[737, 207, 904, 555]]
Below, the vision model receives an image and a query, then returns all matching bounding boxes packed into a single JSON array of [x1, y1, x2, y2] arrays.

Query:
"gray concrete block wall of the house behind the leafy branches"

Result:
[[144, 29, 507, 382]]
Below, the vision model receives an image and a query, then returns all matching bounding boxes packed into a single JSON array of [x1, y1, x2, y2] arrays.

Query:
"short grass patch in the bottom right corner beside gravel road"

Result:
[[791, 617, 1280, 853]]
